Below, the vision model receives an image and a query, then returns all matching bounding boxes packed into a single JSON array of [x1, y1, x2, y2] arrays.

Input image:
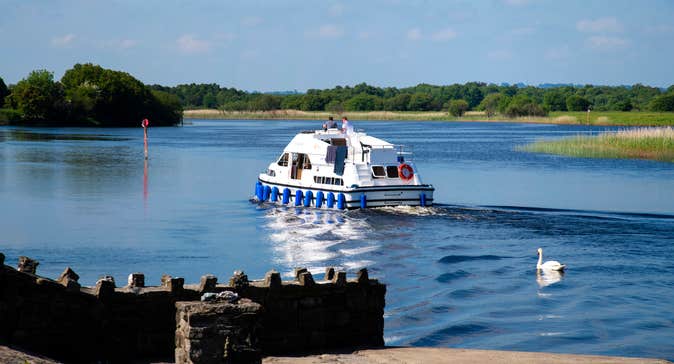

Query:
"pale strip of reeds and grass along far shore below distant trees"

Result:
[[183, 109, 674, 126]]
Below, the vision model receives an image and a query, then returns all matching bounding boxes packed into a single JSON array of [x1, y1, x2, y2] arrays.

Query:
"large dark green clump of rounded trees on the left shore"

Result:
[[0, 64, 182, 127]]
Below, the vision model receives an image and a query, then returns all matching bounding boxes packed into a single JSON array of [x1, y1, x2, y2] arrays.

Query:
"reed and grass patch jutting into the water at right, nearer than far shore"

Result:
[[518, 127, 674, 163]]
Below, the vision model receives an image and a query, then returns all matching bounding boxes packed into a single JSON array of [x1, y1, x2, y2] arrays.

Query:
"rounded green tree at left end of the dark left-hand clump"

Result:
[[11, 70, 64, 121]]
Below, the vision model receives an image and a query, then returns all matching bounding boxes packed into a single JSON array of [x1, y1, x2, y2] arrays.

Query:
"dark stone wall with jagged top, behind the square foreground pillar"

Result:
[[0, 253, 386, 362]]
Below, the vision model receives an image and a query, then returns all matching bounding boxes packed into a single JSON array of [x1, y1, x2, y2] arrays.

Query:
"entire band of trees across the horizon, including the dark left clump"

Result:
[[0, 63, 674, 126]]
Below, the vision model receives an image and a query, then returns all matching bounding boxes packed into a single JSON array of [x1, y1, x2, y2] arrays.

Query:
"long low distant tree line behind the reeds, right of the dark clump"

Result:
[[151, 82, 674, 116]]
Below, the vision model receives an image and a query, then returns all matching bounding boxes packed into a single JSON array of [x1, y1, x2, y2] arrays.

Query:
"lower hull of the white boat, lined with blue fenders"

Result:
[[255, 179, 435, 209]]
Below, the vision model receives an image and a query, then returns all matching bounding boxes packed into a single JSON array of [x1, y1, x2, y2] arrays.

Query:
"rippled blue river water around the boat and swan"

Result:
[[0, 120, 674, 360]]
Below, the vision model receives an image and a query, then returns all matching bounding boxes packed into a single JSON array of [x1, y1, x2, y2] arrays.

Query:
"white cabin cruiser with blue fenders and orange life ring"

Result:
[[255, 129, 435, 209]]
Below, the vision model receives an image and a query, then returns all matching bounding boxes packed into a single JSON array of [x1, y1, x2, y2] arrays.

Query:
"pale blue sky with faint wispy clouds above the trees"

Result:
[[0, 0, 674, 91]]
